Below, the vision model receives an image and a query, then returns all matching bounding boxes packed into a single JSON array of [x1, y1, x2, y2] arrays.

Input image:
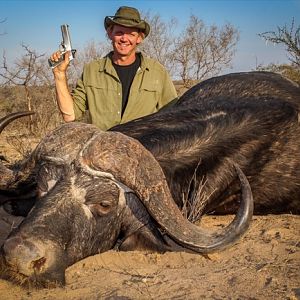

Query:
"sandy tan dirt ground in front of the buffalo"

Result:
[[0, 211, 300, 300]]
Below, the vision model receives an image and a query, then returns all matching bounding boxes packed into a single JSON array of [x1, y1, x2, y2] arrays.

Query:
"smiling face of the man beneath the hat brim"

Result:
[[108, 25, 142, 56]]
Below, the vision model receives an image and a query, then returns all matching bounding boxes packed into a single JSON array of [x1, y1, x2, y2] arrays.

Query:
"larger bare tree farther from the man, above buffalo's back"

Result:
[[172, 15, 239, 87]]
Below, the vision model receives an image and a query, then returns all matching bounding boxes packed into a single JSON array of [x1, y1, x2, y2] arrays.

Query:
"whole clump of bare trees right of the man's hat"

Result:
[[141, 15, 239, 88]]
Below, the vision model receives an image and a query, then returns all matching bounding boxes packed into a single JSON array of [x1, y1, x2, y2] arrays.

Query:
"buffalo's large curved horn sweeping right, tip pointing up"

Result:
[[80, 132, 253, 253]]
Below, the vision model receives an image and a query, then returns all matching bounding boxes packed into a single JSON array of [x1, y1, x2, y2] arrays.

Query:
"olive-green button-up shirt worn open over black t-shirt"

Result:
[[72, 55, 177, 130]]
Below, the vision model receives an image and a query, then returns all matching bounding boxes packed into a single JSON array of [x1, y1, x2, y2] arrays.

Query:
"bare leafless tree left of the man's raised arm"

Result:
[[0, 44, 61, 135]]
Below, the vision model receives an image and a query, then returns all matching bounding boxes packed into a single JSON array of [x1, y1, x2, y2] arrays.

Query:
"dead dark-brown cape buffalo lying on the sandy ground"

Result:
[[0, 72, 300, 284]]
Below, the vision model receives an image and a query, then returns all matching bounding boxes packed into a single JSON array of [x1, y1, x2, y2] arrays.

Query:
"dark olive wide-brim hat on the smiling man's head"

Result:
[[104, 6, 150, 37]]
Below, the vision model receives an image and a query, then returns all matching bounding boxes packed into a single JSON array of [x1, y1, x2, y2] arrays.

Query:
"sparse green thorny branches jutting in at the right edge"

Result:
[[258, 19, 300, 68]]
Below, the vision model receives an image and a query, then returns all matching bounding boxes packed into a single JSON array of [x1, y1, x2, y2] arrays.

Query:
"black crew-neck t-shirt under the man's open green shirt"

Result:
[[113, 54, 141, 115]]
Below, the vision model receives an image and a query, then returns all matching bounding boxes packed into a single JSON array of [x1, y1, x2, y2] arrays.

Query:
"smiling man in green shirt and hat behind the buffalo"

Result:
[[51, 6, 177, 130]]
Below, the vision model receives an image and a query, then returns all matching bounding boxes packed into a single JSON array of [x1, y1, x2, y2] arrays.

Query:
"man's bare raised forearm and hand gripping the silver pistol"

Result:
[[51, 51, 75, 122]]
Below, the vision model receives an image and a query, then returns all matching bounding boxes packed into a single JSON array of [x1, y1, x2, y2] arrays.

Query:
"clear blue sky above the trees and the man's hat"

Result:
[[0, 0, 300, 72]]
